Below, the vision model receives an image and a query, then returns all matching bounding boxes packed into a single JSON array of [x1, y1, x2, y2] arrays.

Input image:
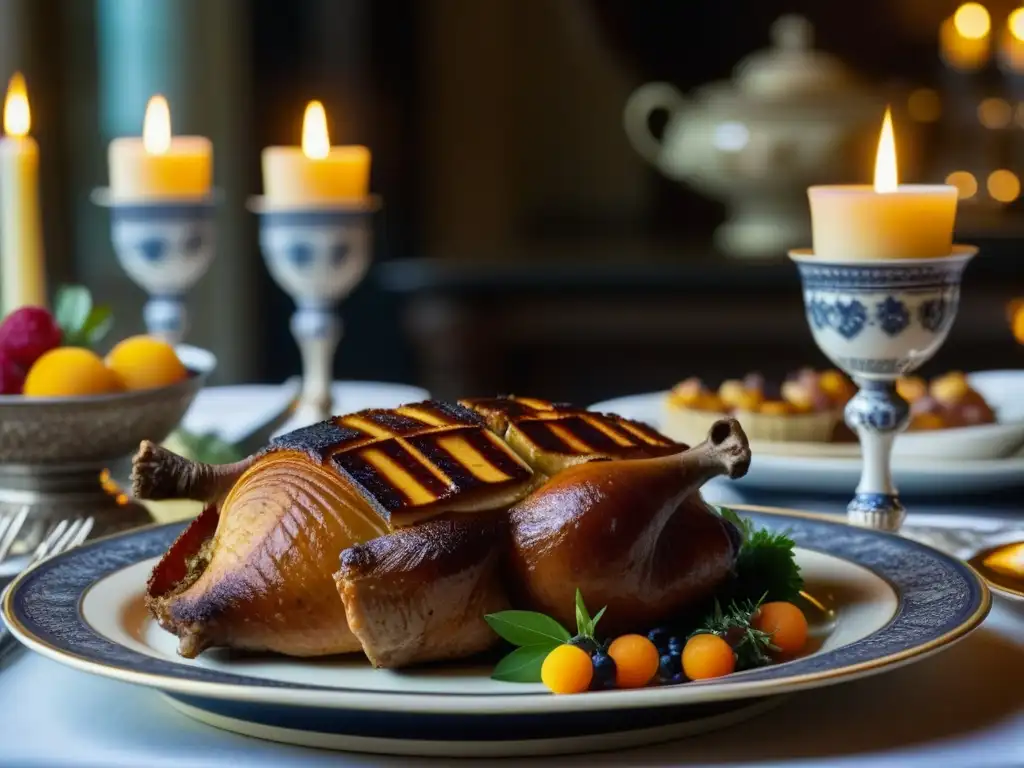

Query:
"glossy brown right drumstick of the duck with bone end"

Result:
[[509, 420, 751, 634]]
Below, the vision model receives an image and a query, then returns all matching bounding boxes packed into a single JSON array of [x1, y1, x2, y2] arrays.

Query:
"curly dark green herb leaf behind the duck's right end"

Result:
[[719, 507, 804, 601]]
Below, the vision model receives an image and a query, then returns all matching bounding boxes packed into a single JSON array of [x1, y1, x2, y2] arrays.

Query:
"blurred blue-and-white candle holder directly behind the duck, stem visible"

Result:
[[250, 196, 380, 431]]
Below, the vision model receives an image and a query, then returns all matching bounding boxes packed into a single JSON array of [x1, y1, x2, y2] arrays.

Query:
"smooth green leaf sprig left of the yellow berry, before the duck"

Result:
[[483, 589, 607, 683]]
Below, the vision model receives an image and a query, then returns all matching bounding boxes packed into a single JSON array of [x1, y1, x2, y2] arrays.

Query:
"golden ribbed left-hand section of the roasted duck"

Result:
[[142, 452, 386, 658]]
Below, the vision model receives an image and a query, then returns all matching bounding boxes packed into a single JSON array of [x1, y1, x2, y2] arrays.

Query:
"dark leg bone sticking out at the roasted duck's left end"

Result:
[[131, 440, 256, 504]]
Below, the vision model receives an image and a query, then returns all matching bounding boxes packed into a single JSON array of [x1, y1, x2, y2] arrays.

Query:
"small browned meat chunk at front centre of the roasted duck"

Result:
[[335, 514, 509, 668]]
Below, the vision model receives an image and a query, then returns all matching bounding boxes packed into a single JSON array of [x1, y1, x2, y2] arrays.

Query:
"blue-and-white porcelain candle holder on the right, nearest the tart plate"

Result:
[[790, 246, 978, 531]]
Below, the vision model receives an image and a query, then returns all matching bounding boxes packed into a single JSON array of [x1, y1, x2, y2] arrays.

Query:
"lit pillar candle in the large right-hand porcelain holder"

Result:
[[808, 111, 956, 261]]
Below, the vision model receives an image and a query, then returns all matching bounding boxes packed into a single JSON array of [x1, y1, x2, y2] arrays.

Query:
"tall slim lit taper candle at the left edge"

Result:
[[0, 73, 47, 314]]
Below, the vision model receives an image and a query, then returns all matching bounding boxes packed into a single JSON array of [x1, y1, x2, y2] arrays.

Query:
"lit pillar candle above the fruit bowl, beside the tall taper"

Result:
[[108, 94, 213, 201]]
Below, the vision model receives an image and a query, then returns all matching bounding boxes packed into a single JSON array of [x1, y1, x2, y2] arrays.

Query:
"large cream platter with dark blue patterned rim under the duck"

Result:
[[3, 507, 990, 757]]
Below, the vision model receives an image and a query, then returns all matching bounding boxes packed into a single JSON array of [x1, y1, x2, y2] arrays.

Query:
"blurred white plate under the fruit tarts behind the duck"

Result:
[[590, 371, 1024, 496]]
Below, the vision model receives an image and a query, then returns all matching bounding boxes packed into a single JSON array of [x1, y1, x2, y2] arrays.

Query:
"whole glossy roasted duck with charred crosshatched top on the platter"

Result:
[[132, 397, 750, 667]]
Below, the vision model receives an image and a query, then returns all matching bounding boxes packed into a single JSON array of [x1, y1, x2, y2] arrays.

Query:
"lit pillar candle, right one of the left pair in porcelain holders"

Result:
[[262, 101, 370, 208]]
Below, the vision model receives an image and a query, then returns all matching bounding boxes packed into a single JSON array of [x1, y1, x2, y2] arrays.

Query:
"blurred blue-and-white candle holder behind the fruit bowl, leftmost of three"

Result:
[[92, 189, 217, 345]]
